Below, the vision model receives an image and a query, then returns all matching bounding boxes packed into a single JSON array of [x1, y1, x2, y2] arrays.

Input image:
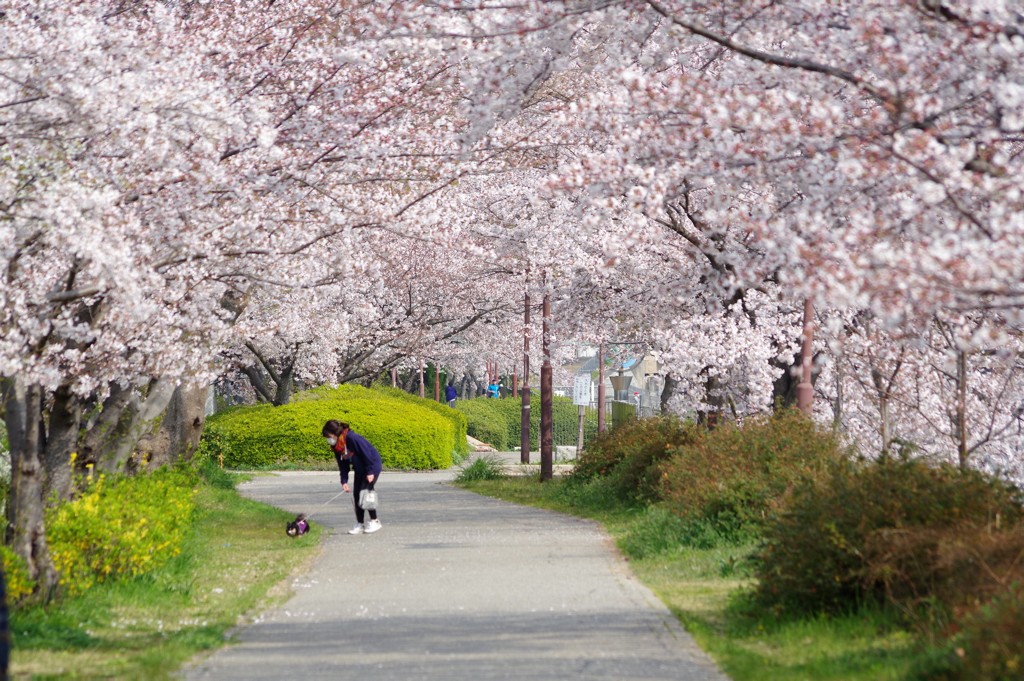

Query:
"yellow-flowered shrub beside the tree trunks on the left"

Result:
[[46, 469, 195, 594]]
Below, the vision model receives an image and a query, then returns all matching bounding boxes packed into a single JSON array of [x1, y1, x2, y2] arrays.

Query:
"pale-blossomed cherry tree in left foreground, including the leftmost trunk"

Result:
[[0, 3, 276, 590]]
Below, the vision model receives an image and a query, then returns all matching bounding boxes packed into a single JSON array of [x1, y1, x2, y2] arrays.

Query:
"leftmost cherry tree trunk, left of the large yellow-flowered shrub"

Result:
[[3, 379, 57, 600]]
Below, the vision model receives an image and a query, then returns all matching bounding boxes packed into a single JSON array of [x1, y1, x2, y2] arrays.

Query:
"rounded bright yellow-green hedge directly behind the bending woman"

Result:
[[200, 385, 456, 470]]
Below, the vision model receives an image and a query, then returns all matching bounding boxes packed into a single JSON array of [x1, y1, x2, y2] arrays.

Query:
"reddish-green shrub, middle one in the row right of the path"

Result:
[[659, 410, 840, 538]]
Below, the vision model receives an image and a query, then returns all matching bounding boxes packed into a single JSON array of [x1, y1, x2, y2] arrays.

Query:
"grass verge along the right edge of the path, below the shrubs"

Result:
[[460, 477, 924, 681]]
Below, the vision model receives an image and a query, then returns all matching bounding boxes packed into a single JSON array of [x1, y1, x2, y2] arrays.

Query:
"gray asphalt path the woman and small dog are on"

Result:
[[184, 471, 726, 681]]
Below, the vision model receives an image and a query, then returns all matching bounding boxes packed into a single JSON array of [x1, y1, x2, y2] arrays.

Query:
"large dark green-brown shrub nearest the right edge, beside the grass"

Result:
[[756, 459, 1021, 612]]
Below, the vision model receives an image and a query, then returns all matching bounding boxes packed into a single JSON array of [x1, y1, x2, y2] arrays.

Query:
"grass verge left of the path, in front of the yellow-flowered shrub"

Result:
[[10, 475, 321, 679]]
